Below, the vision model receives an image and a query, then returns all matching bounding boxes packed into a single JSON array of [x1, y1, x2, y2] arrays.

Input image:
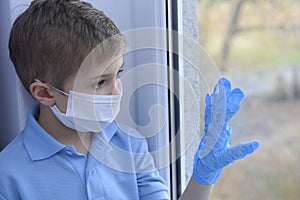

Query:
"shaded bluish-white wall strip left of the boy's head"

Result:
[[0, 0, 32, 150]]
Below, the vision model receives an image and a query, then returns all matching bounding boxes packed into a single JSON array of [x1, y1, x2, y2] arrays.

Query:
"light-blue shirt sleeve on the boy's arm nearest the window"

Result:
[[135, 139, 170, 200]]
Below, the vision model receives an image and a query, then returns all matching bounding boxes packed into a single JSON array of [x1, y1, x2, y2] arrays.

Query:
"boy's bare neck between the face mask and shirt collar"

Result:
[[38, 105, 93, 156]]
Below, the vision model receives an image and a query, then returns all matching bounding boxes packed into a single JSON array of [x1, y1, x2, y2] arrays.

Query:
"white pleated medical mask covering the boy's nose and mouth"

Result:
[[36, 80, 122, 132]]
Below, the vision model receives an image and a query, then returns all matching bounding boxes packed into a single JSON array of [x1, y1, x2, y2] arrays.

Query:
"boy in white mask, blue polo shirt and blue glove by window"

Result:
[[0, 0, 258, 200]]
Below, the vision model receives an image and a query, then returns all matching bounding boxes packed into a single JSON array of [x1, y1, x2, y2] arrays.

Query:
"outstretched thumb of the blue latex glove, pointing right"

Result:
[[219, 141, 259, 167]]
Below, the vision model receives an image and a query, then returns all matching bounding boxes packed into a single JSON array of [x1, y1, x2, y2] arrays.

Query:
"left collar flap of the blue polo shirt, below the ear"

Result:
[[23, 105, 66, 161]]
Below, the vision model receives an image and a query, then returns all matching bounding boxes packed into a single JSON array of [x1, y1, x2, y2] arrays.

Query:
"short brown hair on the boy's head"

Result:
[[9, 0, 125, 91]]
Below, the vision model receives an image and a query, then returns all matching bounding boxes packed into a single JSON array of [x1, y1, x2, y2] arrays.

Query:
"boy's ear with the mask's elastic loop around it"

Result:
[[29, 82, 55, 106]]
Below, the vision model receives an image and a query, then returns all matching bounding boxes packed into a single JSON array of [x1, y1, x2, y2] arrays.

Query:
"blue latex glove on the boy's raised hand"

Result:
[[193, 78, 259, 184]]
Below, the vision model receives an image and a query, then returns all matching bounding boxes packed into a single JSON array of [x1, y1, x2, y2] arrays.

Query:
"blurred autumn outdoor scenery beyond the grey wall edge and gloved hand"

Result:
[[198, 0, 300, 200]]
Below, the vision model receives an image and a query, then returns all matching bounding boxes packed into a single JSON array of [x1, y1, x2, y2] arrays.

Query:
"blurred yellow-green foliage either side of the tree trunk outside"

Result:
[[198, 0, 300, 71]]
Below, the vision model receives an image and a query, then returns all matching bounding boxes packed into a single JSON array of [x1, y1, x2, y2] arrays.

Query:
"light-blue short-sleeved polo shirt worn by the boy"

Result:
[[0, 106, 169, 200]]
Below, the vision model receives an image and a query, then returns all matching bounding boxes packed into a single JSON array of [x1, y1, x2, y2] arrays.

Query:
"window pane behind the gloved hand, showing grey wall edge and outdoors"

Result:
[[172, 0, 300, 200]]
